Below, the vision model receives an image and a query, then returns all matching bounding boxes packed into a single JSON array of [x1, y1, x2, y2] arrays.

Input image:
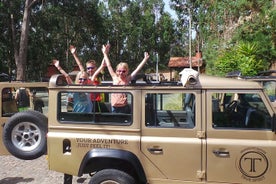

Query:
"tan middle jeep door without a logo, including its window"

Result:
[[141, 89, 204, 183]]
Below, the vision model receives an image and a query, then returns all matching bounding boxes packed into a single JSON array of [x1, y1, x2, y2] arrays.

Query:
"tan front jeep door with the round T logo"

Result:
[[206, 90, 276, 184]]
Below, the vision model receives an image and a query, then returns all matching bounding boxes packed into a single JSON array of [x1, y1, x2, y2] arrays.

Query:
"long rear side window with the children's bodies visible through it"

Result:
[[57, 92, 133, 125]]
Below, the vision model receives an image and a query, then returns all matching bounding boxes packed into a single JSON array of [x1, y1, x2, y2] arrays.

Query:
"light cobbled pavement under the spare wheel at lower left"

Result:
[[0, 156, 89, 184]]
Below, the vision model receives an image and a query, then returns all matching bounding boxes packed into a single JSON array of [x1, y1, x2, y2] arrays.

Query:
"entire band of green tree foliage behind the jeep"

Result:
[[0, 0, 276, 80]]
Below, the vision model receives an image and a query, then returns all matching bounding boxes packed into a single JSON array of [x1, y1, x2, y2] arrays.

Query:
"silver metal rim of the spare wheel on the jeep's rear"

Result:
[[11, 122, 41, 151]]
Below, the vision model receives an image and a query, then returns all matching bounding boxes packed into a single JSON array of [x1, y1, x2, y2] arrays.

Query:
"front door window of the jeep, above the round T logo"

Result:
[[212, 93, 272, 129]]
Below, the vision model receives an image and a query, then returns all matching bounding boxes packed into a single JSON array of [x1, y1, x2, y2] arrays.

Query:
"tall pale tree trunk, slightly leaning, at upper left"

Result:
[[15, 0, 32, 81]]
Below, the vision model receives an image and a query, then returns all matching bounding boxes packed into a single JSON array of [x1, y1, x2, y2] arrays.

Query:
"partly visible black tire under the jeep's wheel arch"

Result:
[[89, 169, 136, 184]]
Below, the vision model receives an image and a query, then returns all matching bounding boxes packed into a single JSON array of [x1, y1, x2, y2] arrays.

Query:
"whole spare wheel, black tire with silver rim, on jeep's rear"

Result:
[[3, 111, 48, 160]]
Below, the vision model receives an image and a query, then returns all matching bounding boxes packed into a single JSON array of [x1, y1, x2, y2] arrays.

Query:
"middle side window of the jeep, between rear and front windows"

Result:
[[145, 93, 195, 128]]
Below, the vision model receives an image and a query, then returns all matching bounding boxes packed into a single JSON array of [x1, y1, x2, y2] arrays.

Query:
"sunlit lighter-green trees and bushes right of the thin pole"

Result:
[[194, 0, 276, 75]]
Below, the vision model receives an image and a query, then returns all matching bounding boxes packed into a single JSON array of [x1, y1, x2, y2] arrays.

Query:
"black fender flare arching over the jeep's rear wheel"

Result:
[[78, 148, 147, 183]]
